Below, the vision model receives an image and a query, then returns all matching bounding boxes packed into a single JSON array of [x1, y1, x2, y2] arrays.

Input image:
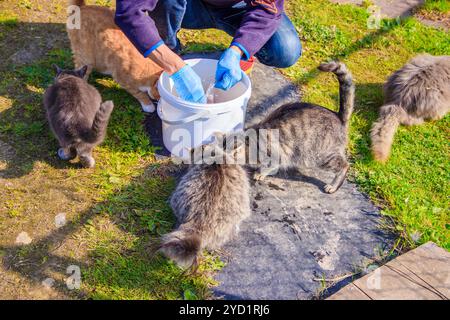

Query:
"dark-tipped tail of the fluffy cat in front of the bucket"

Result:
[[159, 229, 201, 268]]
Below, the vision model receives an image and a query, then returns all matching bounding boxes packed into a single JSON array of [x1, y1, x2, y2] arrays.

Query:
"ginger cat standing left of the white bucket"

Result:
[[67, 0, 163, 112]]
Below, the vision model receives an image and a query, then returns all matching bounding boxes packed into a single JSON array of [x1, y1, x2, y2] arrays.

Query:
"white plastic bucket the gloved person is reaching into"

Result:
[[157, 59, 252, 158]]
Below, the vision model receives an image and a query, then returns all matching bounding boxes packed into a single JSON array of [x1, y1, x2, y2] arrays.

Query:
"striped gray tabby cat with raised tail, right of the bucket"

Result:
[[249, 61, 355, 193]]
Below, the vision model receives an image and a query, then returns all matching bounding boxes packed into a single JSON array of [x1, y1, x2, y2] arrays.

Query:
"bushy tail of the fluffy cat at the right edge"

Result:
[[370, 104, 406, 162]]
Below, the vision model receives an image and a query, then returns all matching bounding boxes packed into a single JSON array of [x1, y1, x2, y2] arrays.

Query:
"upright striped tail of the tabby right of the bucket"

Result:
[[319, 61, 355, 128]]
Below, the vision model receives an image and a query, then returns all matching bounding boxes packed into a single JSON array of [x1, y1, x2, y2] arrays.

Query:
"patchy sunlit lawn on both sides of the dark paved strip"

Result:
[[0, 0, 450, 299]]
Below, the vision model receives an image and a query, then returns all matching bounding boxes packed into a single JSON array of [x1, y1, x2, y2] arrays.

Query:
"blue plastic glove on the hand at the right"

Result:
[[215, 48, 242, 90]]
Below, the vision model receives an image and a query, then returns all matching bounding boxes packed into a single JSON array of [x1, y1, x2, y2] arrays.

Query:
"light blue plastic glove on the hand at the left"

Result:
[[170, 65, 206, 103]]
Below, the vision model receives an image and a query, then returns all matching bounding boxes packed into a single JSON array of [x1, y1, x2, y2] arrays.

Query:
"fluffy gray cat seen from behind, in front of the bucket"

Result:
[[160, 164, 250, 267]]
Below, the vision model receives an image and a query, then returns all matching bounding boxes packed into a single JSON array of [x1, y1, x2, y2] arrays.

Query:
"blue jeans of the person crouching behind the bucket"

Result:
[[150, 0, 302, 68]]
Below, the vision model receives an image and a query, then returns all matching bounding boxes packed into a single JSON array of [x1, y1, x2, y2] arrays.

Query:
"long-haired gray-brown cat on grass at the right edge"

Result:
[[370, 54, 450, 162]]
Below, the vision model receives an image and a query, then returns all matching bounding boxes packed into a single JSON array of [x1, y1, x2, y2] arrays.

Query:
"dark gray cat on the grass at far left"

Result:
[[44, 66, 114, 168]]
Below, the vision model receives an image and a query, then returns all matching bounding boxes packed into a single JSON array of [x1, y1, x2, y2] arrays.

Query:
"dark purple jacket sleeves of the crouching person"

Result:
[[115, 0, 284, 58]]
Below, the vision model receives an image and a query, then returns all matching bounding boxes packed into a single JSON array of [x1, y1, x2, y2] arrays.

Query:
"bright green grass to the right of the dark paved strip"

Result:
[[283, 0, 450, 249]]
